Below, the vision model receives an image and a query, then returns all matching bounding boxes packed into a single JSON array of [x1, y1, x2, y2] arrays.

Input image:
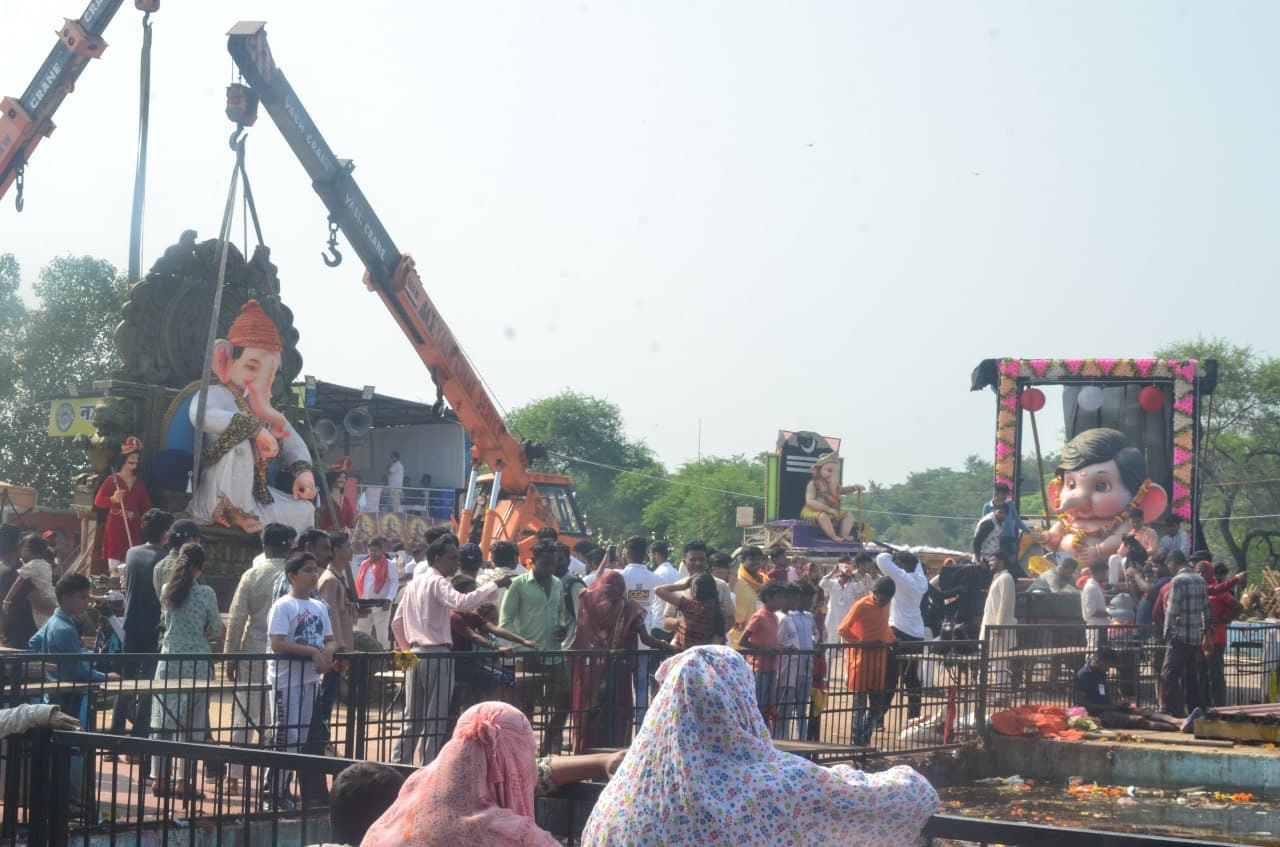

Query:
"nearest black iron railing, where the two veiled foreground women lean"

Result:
[[4, 732, 1239, 847]]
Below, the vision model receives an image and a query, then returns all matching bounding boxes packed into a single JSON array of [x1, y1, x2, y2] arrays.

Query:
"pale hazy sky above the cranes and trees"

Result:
[[0, 0, 1280, 482]]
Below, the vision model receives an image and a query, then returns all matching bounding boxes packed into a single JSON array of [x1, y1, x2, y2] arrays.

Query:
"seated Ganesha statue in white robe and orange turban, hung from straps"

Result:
[[191, 299, 316, 532]]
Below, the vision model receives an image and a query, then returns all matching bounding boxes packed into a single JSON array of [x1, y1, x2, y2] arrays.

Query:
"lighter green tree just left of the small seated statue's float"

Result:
[[644, 455, 764, 550]]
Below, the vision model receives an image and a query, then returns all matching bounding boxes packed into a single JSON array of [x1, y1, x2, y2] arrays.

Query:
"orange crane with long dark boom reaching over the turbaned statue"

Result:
[[227, 20, 586, 555]]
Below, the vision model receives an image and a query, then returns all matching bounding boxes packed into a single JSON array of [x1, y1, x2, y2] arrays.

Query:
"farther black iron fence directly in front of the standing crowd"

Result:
[[0, 641, 984, 777]]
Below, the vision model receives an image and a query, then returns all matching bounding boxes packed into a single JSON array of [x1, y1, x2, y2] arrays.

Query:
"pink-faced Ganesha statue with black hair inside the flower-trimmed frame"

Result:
[[1036, 427, 1169, 566]]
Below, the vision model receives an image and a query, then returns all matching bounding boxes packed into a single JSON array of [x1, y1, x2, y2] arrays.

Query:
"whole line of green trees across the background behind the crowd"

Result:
[[0, 253, 1280, 566]]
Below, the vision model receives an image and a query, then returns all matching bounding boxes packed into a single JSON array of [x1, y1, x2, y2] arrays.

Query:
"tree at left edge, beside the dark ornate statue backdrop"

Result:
[[0, 256, 128, 507]]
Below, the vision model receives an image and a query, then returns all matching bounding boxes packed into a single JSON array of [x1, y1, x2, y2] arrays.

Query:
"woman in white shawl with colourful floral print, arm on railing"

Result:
[[581, 646, 938, 847]]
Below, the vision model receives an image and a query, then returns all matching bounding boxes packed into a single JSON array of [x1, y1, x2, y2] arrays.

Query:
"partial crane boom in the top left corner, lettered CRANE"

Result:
[[0, 0, 123, 203]]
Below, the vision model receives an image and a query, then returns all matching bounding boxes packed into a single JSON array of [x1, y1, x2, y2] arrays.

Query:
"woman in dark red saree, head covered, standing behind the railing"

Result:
[[573, 571, 671, 754]]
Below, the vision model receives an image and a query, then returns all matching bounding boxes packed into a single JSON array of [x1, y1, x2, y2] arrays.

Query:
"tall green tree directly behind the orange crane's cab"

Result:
[[507, 392, 666, 537]]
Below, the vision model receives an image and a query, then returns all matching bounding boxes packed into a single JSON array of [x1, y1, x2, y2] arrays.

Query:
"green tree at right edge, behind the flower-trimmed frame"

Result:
[[1156, 338, 1280, 568]]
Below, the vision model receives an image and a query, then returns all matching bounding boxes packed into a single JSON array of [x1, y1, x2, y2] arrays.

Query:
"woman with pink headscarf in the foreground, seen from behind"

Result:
[[360, 702, 559, 847]]
